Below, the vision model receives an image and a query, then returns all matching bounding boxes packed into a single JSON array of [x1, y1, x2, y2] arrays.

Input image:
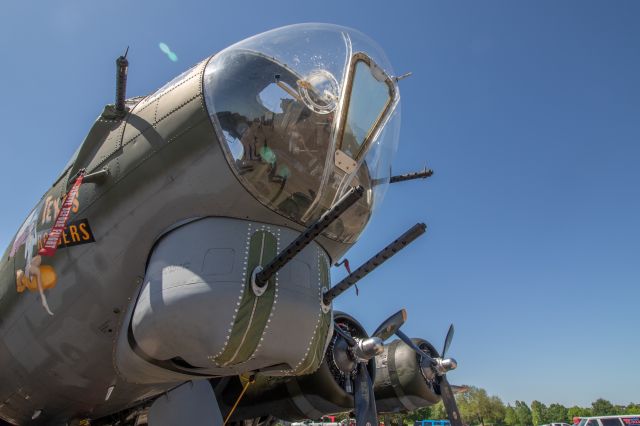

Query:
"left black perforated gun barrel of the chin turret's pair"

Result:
[[255, 186, 364, 287]]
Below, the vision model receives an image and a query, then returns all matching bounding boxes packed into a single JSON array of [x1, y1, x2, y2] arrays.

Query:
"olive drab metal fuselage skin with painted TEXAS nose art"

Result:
[[0, 61, 349, 423]]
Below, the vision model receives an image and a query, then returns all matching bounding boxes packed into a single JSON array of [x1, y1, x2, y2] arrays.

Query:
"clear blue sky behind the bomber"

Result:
[[0, 0, 640, 405]]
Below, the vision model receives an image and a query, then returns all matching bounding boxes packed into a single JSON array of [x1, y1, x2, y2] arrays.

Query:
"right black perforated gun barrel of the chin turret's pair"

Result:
[[322, 223, 427, 305]]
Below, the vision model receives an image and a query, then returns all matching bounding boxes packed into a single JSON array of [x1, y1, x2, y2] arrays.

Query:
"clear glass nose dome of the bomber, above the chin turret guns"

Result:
[[204, 24, 399, 242]]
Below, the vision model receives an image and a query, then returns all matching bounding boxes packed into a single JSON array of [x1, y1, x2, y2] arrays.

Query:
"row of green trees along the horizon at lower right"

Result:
[[387, 387, 640, 426]]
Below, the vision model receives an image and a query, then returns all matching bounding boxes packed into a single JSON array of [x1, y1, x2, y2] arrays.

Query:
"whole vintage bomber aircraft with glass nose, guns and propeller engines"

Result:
[[0, 24, 462, 426]]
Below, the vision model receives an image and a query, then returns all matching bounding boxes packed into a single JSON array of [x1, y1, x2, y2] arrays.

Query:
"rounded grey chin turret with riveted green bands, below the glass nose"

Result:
[[117, 218, 331, 379]]
